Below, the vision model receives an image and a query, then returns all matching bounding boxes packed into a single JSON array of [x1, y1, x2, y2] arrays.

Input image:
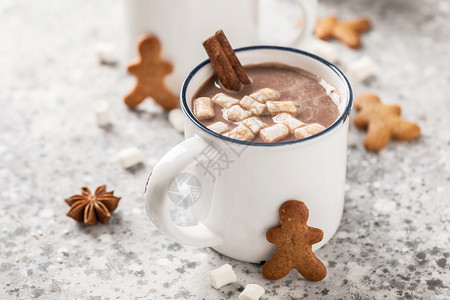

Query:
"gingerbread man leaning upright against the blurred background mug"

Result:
[[124, 35, 178, 110]]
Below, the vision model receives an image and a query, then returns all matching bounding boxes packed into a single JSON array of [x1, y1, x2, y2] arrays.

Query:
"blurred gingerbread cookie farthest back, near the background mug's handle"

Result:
[[314, 16, 370, 48]]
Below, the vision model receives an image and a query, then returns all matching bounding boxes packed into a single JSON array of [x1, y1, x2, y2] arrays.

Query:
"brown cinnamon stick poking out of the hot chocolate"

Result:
[[203, 30, 250, 91]]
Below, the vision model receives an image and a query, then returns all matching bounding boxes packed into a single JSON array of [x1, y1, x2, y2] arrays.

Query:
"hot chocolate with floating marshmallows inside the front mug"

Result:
[[192, 63, 340, 143]]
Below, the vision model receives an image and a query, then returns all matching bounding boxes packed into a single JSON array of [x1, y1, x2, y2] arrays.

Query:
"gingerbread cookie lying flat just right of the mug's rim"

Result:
[[355, 94, 420, 151]]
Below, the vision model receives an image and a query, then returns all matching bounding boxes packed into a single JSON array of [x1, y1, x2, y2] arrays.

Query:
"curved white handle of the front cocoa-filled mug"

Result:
[[145, 135, 222, 247]]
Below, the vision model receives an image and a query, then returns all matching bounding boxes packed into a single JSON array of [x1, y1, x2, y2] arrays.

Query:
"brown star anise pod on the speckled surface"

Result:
[[66, 185, 120, 225]]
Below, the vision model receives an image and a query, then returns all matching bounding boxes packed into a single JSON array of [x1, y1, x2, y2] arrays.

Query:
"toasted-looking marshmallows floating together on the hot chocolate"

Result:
[[194, 88, 325, 143]]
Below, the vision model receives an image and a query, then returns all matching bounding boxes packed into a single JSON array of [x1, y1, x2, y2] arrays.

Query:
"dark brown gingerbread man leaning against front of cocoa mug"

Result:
[[262, 200, 327, 281]]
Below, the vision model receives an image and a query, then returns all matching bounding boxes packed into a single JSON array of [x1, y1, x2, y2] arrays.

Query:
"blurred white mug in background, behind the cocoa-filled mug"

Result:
[[123, 0, 317, 94]]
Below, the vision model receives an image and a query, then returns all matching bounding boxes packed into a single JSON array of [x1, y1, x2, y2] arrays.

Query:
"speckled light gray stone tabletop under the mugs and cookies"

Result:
[[0, 0, 450, 299]]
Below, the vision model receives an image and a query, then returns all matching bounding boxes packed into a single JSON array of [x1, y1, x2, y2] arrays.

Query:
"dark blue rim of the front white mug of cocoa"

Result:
[[180, 46, 353, 147]]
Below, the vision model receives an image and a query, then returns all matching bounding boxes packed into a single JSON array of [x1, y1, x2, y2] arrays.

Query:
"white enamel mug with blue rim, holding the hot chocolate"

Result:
[[145, 46, 353, 263]]
